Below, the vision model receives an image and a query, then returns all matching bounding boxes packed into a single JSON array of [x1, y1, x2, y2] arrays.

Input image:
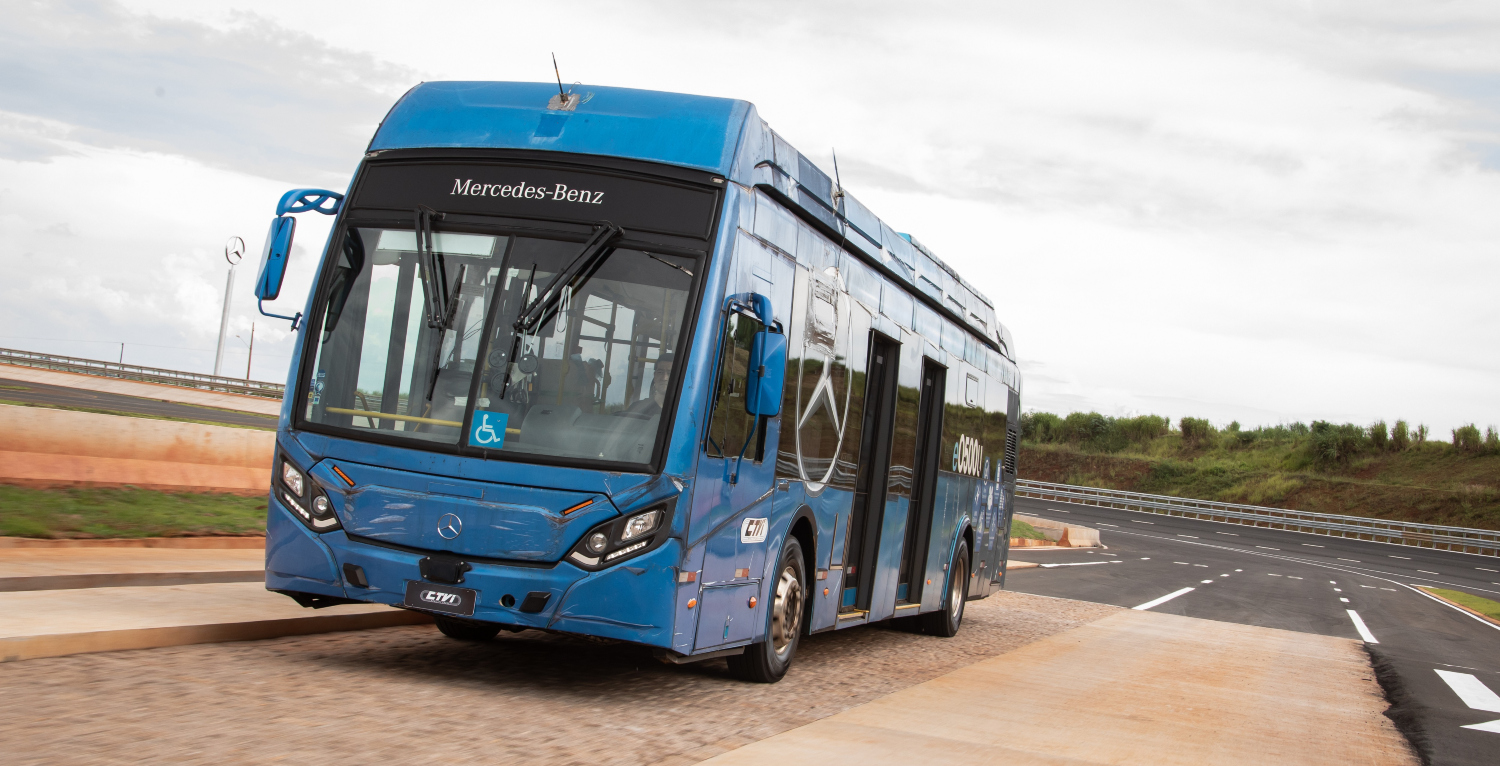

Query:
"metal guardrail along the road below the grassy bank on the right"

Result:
[[1016, 478, 1500, 556]]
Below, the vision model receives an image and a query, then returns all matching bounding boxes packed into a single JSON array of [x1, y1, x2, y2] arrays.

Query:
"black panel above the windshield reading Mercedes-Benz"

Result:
[[354, 163, 716, 238]]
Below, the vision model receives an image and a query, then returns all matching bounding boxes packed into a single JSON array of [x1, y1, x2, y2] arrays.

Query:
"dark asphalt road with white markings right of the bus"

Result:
[[1007, 498, 1500, 766]]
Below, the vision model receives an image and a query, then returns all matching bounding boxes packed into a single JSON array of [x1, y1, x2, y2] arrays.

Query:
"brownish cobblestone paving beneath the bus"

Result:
[[0, 592, 1119, 766]]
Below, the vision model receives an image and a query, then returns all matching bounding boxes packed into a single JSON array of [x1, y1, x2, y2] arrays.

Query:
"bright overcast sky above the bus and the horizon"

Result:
[[0, 0, 1500, 436]]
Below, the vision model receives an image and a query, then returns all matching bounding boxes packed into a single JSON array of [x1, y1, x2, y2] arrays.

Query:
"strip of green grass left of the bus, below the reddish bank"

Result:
[[0, 486, 266, 538]]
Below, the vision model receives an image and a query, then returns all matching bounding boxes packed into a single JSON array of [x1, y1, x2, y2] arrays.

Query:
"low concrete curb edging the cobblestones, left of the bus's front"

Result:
[[0, 609, 432, 663]]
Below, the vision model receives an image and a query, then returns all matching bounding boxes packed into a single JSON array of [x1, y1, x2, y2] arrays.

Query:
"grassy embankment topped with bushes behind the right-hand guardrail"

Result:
[[1019, 412, 1500, 529]]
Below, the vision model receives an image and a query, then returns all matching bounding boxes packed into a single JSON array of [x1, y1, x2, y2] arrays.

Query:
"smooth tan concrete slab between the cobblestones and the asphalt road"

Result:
[[707, 612, 1418, 766]]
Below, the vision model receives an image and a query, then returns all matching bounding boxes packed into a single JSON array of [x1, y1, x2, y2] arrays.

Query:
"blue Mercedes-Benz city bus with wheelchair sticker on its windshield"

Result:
[[255, 82, 1022, 682]]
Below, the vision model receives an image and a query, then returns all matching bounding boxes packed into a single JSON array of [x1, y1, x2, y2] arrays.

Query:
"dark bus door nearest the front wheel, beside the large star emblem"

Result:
[[839, 333, 902, 613]]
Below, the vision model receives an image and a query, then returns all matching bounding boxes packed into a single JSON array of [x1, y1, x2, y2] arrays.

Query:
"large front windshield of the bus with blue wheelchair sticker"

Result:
[[305, 226, 699, 463]]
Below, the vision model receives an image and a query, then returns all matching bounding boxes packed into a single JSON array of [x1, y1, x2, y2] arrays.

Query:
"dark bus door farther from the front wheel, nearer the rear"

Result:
[[896, 357, 948, 604]]
